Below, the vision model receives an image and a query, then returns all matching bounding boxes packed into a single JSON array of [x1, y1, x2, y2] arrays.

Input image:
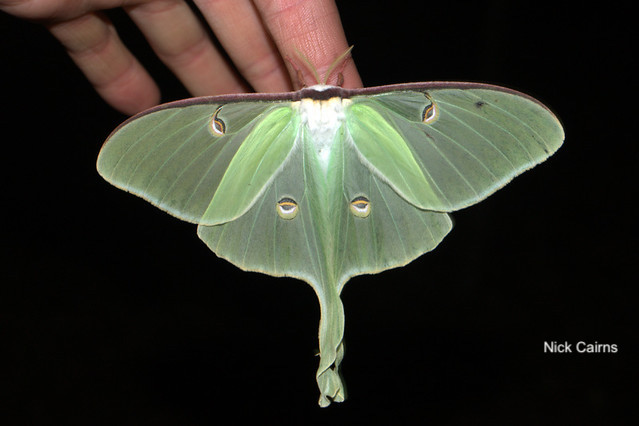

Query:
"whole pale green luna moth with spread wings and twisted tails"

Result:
[[97, 53, 564, 407]]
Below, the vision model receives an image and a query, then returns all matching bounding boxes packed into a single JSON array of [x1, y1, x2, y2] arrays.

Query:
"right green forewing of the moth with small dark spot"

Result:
[[347, 83, 564, 212]]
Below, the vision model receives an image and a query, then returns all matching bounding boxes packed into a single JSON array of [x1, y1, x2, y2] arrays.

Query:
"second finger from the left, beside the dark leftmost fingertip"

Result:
[[126, 0, 248, 96]]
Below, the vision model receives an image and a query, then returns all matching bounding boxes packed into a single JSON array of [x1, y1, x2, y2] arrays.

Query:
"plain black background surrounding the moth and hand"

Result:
[[0, 1, 639, 425]]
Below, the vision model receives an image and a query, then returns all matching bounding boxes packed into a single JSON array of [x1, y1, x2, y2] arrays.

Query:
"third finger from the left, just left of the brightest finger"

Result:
[[195, 0, 293, 92]]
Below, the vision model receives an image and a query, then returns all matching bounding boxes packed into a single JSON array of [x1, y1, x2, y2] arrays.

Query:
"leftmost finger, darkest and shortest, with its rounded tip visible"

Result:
[[48, 13, 160, 114]]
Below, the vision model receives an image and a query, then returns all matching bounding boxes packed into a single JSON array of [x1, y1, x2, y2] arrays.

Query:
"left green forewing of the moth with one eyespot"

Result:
[[97, 98, 295, 224]]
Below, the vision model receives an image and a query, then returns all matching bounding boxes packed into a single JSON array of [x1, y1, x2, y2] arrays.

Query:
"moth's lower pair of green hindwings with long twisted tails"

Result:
[[198, 124, 452, 406]]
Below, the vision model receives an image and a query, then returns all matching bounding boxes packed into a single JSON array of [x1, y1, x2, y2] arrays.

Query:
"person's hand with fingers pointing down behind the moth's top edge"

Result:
[[0, 0, 362, 114]]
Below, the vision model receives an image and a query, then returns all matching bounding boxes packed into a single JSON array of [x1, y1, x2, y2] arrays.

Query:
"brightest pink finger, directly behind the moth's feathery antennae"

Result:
[[255, 0, 362, 88]]
